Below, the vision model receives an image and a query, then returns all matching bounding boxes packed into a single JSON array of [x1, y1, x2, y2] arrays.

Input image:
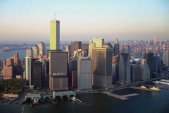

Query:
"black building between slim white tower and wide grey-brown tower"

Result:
[[31, 59, 46, 89]]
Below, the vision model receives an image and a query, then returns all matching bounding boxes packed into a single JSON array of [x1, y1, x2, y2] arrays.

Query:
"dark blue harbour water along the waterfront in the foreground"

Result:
[[0, 89, 169, 113]]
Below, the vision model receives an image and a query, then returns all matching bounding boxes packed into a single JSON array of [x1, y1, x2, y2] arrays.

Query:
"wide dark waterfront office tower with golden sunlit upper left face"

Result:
[[91, 48, 112, 88]]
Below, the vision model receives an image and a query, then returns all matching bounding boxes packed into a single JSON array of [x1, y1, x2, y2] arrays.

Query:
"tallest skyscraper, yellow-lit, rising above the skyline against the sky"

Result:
[[50, 20, 60, 50]]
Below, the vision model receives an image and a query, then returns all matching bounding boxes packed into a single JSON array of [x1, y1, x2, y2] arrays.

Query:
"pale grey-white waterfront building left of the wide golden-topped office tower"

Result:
[[77, 58, 92, 90]]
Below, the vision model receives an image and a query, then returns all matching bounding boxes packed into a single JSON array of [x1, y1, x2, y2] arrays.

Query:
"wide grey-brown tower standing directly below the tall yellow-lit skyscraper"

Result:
[[49, 50, 68, 90]]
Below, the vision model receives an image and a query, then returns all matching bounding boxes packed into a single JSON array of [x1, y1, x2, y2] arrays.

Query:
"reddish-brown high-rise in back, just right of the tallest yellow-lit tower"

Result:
[[71, 41, 82, 56]]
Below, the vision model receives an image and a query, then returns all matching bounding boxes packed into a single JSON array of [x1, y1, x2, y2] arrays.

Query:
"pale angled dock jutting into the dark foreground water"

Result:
[[103, 92, 139, 100]]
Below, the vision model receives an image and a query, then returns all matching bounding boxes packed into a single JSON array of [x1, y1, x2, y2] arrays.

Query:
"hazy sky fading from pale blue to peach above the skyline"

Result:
[[0, 0, 169, 41]]
